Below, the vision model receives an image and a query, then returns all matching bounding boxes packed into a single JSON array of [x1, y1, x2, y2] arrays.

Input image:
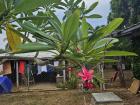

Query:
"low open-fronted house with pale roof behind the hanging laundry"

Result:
[[0, 52, 65, 87]]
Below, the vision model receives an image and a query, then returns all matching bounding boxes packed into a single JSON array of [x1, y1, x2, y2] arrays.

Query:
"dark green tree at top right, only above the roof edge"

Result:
[[108, 0, 140, 26]]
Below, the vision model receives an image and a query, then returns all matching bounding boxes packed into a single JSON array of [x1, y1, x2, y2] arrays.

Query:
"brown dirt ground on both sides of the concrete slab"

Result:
[[0, 88, 140, 105]]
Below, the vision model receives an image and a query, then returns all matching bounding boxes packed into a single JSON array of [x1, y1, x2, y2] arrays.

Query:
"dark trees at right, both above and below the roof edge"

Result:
[[108, 0, 140, 75]]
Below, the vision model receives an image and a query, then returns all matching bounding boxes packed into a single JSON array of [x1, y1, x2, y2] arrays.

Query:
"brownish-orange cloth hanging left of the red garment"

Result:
[[3, 61, 12, 75]]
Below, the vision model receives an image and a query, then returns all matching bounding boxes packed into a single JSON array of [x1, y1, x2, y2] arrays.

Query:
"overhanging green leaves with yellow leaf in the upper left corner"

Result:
[[0, 0, 60, 52]]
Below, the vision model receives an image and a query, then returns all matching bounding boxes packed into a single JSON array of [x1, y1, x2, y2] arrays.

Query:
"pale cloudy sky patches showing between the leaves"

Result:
[[0, 0, 111, 49]]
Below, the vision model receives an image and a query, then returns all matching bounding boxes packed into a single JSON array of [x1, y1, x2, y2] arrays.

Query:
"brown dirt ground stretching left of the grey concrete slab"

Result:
[[0, 90, 90, 105]]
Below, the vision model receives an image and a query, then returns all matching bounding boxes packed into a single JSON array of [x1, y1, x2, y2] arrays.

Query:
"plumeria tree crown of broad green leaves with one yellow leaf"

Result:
[[0, 0, 136, 90]]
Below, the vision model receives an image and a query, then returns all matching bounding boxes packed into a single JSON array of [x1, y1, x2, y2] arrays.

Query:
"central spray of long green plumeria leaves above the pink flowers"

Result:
[[0, 0, 135, 60]]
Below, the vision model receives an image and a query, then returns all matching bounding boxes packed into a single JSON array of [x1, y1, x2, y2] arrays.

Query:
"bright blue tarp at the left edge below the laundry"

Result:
[[0, 76, 13, 94]]
